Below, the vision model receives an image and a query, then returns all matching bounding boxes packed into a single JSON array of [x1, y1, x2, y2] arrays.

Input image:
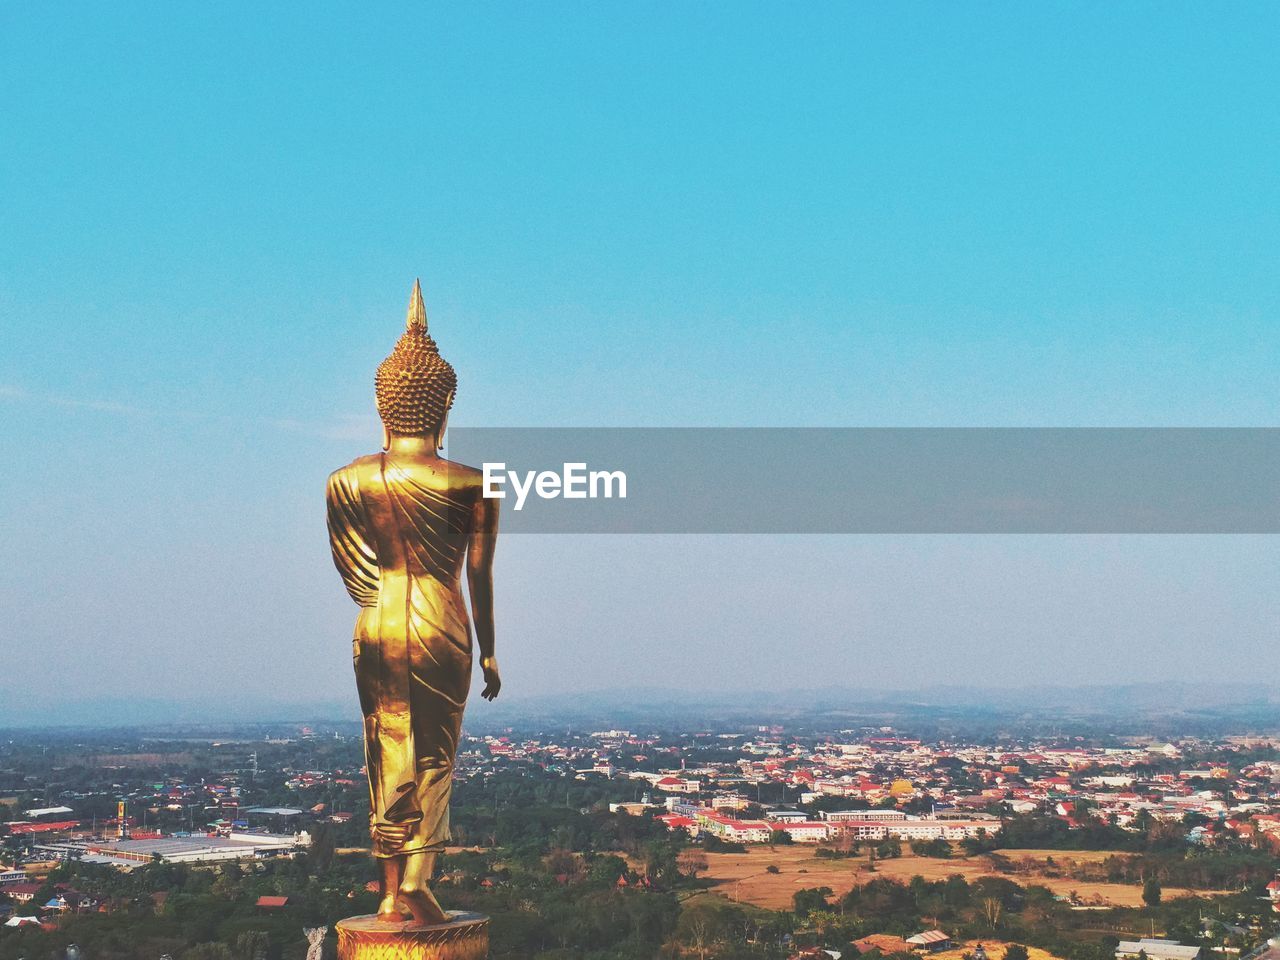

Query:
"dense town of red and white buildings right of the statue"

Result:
[[462, 727, 1280, 852]]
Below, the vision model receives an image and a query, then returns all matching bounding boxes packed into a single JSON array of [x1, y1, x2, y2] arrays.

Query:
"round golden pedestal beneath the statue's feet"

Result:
[[338, 910, 489, 960]]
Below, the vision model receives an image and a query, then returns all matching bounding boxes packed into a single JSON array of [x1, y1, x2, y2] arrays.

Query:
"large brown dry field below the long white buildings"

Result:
[[705, 845, 1224, 911]]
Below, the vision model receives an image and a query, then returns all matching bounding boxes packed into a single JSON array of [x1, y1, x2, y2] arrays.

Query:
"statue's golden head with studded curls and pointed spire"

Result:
[[374, 280, 458, 436]]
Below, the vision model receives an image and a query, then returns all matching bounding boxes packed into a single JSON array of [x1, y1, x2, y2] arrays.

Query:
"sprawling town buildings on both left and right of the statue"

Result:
[[0, 727, 1280, 904]]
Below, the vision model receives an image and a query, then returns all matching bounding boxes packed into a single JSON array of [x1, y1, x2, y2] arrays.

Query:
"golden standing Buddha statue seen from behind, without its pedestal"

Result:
[[328, 282, 502, 925]]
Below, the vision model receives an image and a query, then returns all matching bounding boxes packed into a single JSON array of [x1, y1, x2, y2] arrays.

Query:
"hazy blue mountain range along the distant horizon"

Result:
[[0, 681, 1280, 736]]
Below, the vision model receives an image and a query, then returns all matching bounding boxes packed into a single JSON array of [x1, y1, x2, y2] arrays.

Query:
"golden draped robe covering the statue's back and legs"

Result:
[[328, 453, 476, 856]]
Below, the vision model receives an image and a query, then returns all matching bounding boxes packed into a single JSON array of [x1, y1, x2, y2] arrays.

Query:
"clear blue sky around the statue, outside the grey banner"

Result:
[[0, 3, 1280, 716]]
